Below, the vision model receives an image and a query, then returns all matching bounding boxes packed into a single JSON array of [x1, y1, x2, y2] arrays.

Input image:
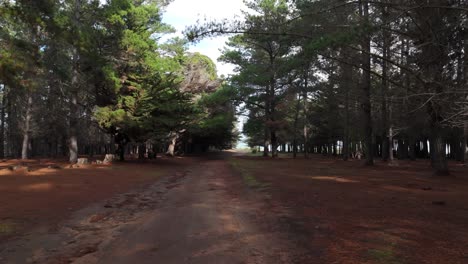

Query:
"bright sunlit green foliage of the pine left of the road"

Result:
[[94, 0, 195, 140]]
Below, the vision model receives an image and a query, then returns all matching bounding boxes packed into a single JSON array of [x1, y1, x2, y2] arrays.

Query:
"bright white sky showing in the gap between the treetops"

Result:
[[163, 0, 246, 76]]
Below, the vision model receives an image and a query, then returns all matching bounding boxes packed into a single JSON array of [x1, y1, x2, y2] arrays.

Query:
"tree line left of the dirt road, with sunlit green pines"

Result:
[[0, 0, 236, 162]]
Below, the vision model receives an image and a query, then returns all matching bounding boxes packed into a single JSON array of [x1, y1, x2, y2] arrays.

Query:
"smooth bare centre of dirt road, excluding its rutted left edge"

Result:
[[95, 156, 308, 264]]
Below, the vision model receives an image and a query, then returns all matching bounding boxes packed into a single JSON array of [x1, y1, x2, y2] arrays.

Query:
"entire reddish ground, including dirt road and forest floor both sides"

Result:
[[0, 153, 468, 264]]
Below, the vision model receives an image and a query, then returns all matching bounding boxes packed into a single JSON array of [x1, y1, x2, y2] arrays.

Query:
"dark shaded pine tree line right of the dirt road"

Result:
[[185, 0, 468, 175]]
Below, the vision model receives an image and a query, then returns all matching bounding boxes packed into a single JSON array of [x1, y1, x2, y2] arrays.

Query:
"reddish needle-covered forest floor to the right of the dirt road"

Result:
[[230, 155, 468, 264]]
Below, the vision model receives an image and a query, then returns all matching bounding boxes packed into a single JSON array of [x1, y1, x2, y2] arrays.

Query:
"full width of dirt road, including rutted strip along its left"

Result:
[[0, 156, 307, 264]]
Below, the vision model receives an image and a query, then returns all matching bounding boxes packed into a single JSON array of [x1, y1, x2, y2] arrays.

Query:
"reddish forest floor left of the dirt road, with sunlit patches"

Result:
[[0, 158, 192, 240]]
